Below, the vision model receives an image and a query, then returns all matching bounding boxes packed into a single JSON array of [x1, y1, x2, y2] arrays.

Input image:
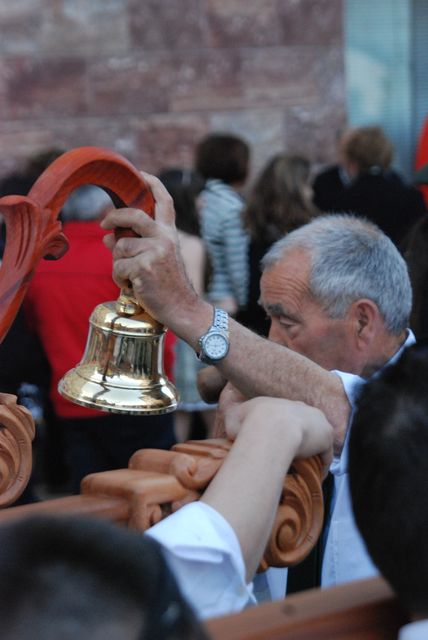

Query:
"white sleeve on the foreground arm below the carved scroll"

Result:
[[145, 502, 256, 618]]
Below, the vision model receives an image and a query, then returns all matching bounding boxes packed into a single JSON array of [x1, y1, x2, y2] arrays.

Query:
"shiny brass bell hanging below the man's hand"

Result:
[[58, 296, 177, 415]]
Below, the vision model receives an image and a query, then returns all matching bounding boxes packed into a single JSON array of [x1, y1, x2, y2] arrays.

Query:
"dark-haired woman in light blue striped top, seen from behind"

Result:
[[195, 134, 250, 315]]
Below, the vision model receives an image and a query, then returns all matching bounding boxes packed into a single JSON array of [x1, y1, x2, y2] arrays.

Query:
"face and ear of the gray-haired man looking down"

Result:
[[260, 249, 360, 373]]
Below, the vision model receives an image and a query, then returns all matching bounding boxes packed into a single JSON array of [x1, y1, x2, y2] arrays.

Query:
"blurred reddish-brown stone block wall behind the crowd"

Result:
[[0, 0, 346, 182]]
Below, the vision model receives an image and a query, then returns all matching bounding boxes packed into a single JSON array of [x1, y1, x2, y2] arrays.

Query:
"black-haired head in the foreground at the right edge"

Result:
[[349, 341, 428, 617]]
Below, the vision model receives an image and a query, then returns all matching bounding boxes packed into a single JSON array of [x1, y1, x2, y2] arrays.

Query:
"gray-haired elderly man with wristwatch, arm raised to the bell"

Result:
[[103, 174, 413, 586]]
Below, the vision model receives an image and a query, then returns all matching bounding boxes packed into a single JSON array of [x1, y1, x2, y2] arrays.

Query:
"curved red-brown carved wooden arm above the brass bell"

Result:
[[0, 147, 154, 341]]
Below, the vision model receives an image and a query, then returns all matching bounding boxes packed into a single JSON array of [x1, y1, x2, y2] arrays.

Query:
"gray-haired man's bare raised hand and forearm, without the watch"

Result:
[[102, 173, 350, 441]]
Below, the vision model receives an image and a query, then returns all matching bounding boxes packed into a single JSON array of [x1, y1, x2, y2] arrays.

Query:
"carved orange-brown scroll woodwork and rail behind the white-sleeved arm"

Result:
[[0, 432, 322, 570]]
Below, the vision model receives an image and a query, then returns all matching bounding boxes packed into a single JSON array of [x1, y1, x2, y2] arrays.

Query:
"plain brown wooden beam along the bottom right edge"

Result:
[[207, 578, 408, 640]]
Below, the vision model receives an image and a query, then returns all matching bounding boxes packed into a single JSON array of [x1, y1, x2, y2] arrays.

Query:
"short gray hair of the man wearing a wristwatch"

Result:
[[261, 214, 412, 334]]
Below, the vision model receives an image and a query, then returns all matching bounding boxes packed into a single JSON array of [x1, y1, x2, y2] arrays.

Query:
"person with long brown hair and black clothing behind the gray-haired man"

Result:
[[236, 154, 318, 335]]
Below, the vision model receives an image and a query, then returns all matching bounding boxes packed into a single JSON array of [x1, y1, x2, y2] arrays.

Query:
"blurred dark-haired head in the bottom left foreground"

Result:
[[0, 516, 207, 640]]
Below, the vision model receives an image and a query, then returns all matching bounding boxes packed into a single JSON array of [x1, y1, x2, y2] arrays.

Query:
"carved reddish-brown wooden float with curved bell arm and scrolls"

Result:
[[0, 147, 323, 567]]
